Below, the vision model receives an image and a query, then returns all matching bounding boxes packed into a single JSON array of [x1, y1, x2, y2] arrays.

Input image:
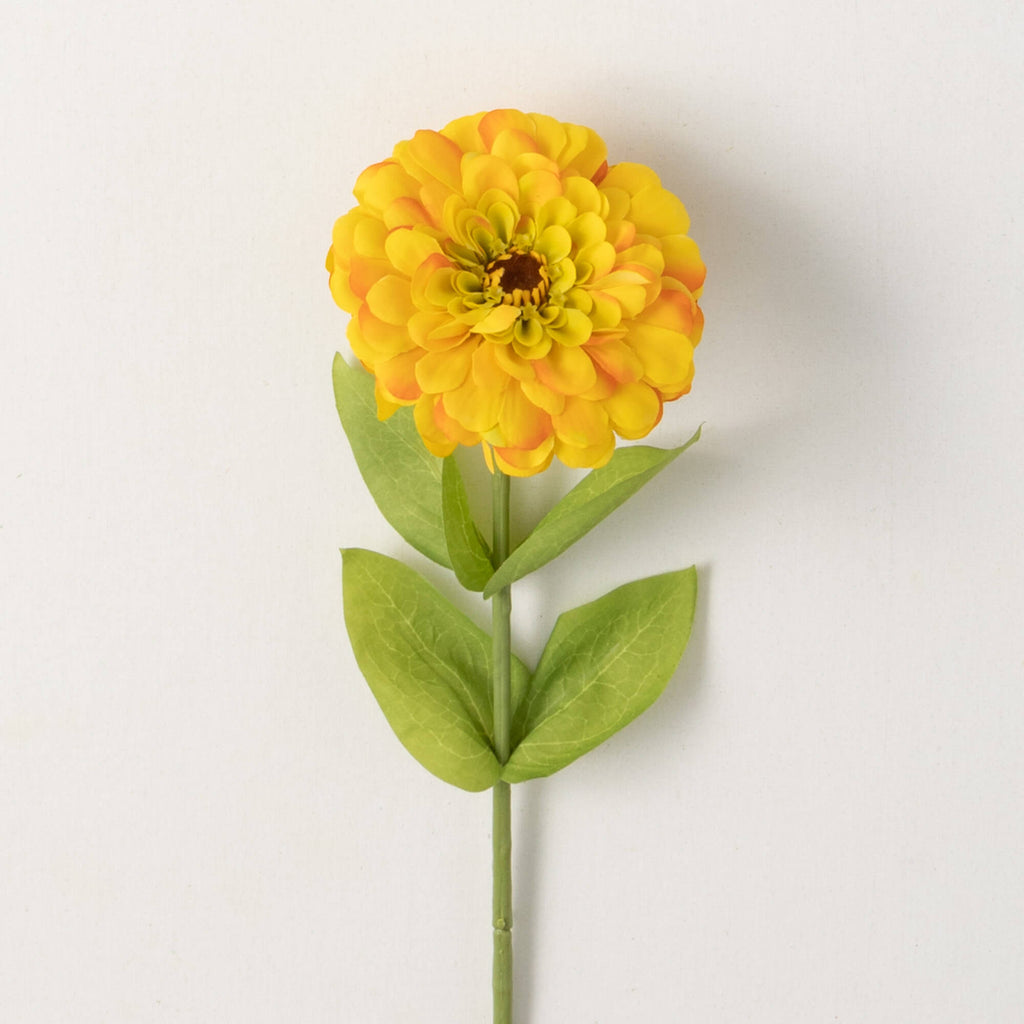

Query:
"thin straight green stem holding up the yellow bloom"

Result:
[[490, 469, 512, 1024]]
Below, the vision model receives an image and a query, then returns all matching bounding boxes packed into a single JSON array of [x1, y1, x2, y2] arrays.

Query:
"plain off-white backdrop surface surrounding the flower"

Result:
[[0, 0, 1024, 1024]]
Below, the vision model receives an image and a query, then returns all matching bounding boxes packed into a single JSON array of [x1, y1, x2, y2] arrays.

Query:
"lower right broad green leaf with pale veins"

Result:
[[502, 567, 696, 782]]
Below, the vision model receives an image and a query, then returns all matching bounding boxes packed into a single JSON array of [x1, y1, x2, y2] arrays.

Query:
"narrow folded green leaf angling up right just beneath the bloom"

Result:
[[483, 428, 700, 598]]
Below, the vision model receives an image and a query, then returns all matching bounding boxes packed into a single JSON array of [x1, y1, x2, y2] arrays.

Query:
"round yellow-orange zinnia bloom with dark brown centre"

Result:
[[327, 110, 705, 476]]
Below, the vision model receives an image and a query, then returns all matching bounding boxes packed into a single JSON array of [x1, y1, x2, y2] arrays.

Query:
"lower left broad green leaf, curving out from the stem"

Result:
[[342, 548, 529, 792]]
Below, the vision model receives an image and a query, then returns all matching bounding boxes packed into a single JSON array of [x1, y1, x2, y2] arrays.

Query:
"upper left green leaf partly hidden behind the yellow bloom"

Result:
[[334, 354, 452, 568]]
